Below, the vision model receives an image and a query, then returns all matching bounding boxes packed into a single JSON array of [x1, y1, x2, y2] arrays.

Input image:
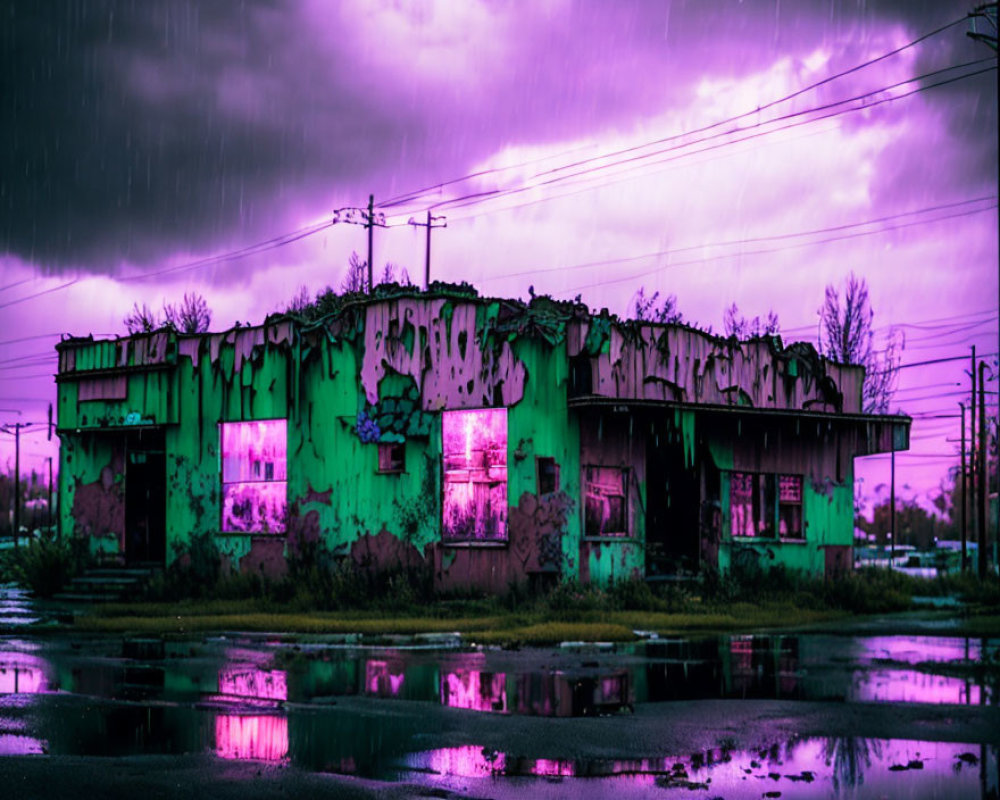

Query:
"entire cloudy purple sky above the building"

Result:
[[0, 0, 997, 512]]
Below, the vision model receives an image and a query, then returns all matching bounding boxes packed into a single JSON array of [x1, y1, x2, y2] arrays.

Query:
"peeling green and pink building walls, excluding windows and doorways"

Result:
[[58, 292, 912, 592]]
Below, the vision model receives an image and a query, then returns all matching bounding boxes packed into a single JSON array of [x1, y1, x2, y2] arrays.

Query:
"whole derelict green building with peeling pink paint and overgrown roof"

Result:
[[57, 284, 910, 592]]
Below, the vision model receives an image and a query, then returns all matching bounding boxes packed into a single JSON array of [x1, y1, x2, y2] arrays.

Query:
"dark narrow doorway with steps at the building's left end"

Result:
[[125, 429, 167, 566]]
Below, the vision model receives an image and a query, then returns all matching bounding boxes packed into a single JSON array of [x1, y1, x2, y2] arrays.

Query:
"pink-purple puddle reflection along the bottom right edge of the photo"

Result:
[[400, 738, 998, 798]]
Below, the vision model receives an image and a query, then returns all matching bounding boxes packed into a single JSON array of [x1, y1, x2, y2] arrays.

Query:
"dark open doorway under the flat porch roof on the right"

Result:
[[646, 421, 701, 578]]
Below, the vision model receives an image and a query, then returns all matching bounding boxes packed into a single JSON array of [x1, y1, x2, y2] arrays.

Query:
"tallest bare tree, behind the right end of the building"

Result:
[[819, 272, 906, 414]]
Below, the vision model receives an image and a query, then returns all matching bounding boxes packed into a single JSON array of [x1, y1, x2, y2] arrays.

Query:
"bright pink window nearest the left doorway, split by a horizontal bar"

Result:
[[219, 419, 288, 533]]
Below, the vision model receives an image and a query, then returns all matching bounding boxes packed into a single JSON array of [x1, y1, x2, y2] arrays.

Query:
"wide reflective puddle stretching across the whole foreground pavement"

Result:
[[0, 636, 1000, 798]]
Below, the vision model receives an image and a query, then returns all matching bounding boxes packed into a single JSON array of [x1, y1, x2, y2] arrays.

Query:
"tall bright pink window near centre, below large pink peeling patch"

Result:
[[441, 408, 507, 541]]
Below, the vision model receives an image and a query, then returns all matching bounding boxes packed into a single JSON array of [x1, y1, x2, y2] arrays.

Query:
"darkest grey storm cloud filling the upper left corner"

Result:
[[0, 0, 406, 270]]
